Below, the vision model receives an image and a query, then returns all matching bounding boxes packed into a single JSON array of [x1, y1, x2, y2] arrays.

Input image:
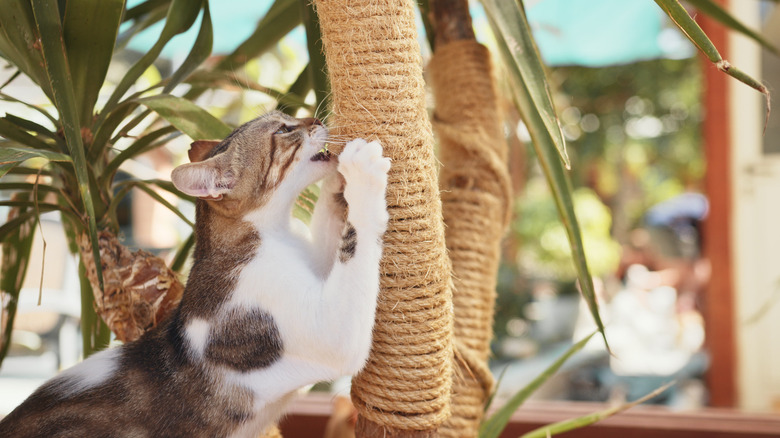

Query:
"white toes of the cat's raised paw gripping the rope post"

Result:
[[338, 138, 390, 191]]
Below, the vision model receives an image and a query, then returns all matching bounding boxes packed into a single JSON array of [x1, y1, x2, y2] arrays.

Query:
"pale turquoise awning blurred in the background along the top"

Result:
[[128, 0, 694, 67]]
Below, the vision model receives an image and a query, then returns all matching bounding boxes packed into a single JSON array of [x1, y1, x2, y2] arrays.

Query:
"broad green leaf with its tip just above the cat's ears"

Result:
[[138, 94, 232, 140]]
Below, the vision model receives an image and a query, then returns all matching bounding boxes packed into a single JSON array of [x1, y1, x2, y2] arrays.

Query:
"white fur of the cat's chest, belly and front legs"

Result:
[[226, 140, 390, 424]]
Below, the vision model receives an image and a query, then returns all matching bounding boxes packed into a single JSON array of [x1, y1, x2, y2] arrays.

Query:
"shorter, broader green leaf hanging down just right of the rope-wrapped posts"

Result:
[[482, 0, 571, 168]]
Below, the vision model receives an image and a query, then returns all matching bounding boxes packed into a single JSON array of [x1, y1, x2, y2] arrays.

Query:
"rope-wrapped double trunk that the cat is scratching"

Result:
[[315, 0, 510, 437]]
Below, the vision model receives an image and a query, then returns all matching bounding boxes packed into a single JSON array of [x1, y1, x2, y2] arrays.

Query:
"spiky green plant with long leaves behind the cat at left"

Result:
[[0, 0, 320, 361]]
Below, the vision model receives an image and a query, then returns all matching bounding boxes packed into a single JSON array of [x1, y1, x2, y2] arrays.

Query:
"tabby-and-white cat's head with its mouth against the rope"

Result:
[[171, 112, 336, 214]]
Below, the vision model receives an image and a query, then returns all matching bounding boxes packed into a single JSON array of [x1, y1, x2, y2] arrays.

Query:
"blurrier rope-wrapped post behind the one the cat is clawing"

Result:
[[429, 0, 512, 437]]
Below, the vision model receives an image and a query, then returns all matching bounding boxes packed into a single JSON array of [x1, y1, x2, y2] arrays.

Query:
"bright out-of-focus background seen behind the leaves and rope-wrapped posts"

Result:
[[0, 0, 780, 415]]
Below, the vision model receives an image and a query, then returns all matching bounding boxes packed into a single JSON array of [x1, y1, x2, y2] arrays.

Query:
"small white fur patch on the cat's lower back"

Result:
[[51, 348, 121, 397]]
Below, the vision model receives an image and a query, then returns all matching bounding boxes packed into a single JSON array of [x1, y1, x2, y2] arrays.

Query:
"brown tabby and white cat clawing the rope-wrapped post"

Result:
[[0, 112, 390, 438]]
